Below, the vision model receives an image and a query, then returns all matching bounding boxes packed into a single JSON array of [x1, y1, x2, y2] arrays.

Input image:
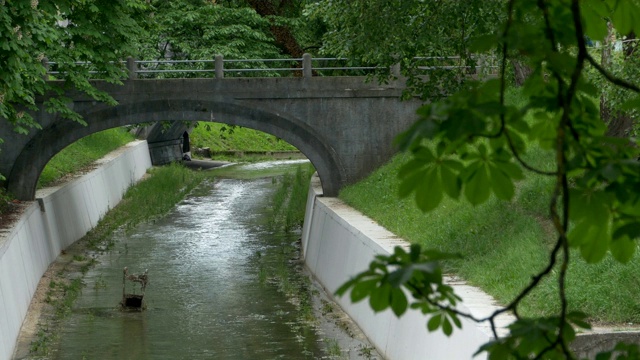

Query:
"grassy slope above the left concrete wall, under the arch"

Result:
[[38, 128, 134, 188]]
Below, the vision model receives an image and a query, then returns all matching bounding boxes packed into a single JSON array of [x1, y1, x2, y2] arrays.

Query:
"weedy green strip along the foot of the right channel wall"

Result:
[[262, 164, 376, 359]]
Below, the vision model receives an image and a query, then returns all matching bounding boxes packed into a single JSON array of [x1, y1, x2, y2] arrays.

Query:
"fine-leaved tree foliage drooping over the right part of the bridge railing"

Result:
[[306, 0, 502, 98]]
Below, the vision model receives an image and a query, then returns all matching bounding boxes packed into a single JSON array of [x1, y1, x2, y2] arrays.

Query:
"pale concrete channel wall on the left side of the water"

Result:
[[0, 141, 151, 359]]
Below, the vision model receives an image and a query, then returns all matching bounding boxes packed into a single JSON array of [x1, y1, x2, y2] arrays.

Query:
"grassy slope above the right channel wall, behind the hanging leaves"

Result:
[[340, 92, 640, 324]]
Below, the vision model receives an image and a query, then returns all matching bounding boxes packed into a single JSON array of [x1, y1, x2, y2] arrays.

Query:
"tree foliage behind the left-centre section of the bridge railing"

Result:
[[134, 0, 321, 77]]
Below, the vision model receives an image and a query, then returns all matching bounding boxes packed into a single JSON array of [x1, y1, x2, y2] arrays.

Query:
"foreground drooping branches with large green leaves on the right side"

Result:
[[338, 0, 640, 359]]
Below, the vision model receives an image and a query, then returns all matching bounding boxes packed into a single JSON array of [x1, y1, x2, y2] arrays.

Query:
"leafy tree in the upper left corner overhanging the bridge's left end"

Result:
[[0, 0, 146, 133]]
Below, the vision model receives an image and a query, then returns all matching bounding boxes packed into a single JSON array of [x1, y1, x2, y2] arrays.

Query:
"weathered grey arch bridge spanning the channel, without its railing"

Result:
[[0, 76, 419, 200]]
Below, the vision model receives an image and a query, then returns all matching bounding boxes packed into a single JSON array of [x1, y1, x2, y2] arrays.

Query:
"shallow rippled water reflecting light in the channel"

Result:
[[57, 164, 322, 359]]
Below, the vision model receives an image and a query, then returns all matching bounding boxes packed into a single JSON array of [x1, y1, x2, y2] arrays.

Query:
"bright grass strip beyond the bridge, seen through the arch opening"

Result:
[[189, 122, 297, 151]]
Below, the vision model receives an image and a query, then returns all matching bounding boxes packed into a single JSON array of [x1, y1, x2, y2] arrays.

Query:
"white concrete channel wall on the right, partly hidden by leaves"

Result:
[[302, 173, 511, 360]]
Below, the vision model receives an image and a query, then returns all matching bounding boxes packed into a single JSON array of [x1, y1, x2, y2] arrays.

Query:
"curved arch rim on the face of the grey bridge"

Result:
[[7, 98, 347, 200]]
